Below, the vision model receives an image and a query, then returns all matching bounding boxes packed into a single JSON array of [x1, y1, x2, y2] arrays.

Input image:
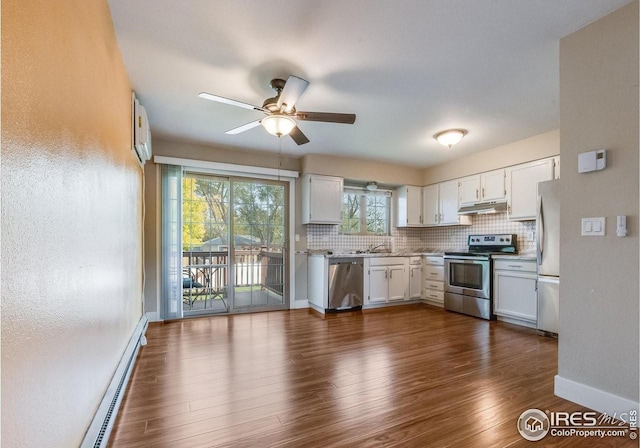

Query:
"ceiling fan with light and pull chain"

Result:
[[198, 75, 356, 145]]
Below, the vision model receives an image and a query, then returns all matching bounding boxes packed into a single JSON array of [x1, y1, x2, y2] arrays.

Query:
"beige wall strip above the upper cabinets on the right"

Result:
[[422, 130, 560, 185]]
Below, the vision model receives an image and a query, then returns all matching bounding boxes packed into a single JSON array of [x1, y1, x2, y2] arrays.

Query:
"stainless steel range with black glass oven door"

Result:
[[444, 234, 518, 320]]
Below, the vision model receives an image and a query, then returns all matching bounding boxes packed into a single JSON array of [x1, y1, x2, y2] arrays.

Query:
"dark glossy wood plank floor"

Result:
[[110, 305, 638, 448]]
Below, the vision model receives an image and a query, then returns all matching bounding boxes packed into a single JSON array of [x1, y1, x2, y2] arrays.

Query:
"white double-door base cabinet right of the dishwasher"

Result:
[[367, 257, 408, 304]]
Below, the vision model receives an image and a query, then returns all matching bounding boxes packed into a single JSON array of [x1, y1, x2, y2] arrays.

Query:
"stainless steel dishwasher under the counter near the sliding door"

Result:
[[328, 257, 364, 311]]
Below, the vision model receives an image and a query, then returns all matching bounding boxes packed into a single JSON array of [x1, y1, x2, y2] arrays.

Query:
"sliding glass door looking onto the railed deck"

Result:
[[182, 172, 288, 316]]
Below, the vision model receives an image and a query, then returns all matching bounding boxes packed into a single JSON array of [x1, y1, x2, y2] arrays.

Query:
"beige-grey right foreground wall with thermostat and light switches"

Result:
[[556, 1, 640, 412]]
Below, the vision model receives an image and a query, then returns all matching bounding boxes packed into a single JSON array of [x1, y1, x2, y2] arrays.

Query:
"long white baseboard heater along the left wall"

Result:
[[80, 316, 149, 448]]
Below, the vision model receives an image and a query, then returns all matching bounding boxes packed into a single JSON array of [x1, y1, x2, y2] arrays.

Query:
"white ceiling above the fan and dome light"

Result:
[[109, 0, 629, 167]]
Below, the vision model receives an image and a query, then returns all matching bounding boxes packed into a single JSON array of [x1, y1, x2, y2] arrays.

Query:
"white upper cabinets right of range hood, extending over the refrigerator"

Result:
[[507, 158, 554, 221]]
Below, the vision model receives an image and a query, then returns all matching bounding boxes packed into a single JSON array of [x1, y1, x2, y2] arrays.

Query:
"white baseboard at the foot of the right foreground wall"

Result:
[[554, 375, 639, 416]]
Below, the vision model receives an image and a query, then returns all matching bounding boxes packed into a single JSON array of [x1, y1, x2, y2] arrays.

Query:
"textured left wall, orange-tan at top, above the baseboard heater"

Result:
[[1, 0, 142, 448]]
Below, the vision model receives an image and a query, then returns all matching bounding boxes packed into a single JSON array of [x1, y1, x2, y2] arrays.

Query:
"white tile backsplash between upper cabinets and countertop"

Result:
[[307, 213, 536, 253]]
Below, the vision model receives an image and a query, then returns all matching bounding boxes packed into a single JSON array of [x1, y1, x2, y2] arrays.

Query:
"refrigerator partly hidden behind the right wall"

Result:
[[536, 180, 560, 335]]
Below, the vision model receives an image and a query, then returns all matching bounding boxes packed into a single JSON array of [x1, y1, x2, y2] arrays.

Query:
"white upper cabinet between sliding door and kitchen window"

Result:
[[301, 174, 344, 224]]
